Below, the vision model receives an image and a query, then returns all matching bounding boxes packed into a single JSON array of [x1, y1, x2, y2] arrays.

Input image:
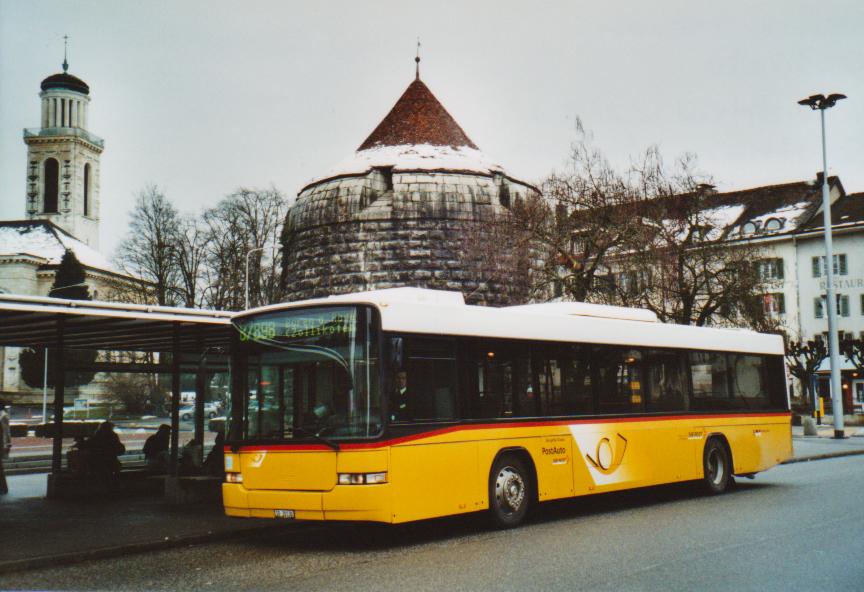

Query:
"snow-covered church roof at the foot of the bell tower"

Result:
[[0, 220, 122, 274]]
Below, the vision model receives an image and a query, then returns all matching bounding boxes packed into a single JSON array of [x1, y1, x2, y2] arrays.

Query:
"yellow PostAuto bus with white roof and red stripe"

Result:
[[223, 288, 792, 527]]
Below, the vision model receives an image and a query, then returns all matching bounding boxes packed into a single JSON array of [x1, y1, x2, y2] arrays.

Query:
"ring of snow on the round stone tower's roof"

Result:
[[309, 144, 504, 184]]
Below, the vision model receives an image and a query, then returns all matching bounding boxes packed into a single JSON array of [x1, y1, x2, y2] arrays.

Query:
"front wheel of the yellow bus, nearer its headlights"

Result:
[[489, 455, 532, 528]]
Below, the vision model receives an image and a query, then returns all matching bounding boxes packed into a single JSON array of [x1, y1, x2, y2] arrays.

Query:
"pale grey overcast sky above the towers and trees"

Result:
[[0, 0, 864, 253]]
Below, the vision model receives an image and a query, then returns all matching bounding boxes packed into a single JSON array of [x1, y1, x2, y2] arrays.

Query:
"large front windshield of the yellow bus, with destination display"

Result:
[[233, 306, 382, 443]]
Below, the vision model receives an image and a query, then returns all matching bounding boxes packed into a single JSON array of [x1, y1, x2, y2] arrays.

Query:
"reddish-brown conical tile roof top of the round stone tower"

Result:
[[357, 78, 477, 150]]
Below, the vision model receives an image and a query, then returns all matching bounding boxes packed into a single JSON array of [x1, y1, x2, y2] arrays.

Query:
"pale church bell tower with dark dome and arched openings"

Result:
[[24, 48, 104, 249]]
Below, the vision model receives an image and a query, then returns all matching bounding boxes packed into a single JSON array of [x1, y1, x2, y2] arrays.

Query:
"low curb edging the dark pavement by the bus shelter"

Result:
[[0, 524, 306, 574]]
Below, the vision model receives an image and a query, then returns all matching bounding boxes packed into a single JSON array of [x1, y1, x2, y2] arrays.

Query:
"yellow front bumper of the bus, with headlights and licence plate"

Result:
[[222, 483, 393, 522]]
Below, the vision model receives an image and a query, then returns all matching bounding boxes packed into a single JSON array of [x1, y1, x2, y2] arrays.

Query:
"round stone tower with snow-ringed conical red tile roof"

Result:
[[283, 72, 536, 305]]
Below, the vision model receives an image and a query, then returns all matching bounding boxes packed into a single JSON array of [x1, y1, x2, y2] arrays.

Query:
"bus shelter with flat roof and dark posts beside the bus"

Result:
[[0, 294, 232, 497]]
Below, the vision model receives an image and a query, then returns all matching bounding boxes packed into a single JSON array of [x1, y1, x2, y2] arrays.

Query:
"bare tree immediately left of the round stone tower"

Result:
[[203, 188, 287, 310]]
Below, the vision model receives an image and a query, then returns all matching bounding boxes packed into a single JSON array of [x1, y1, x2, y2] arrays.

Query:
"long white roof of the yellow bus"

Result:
[[235, 288, 784, 355]]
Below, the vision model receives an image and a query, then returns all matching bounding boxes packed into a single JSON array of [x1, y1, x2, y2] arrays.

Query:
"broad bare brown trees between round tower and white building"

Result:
[[502, 126, 776, 329]]
